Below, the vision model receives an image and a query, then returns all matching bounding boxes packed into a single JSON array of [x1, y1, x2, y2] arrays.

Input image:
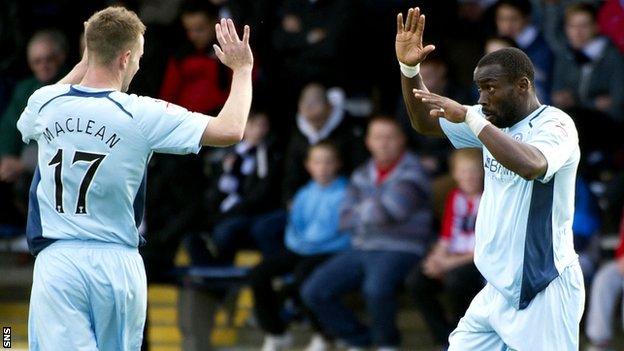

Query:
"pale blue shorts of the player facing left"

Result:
[[449, 263, 585, 351]]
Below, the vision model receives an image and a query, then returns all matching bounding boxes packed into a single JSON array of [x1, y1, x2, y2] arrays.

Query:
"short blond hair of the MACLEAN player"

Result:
[[85, 7, 145, 64]]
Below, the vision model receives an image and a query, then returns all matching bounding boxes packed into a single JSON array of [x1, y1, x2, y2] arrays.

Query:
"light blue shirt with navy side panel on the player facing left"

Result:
[[440, 105, 580, 309]]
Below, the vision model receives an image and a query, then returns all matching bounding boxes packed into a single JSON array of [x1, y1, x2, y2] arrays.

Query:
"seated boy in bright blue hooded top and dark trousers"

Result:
[[250, 141, 350, 351]]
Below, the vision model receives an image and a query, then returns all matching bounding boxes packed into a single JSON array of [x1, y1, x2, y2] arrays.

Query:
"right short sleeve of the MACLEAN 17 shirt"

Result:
[[136, 97, 212, 154]]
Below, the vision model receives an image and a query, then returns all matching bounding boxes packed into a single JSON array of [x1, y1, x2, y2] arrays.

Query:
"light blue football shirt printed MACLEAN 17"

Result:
[[17, 84, 210, 255]]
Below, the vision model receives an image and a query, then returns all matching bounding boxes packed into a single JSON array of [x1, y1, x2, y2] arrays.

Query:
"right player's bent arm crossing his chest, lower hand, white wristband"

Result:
[[413, 90, 548, 180]]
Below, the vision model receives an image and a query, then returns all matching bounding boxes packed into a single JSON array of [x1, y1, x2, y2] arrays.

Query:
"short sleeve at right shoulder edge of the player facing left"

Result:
[[527, 114, 578, 183]]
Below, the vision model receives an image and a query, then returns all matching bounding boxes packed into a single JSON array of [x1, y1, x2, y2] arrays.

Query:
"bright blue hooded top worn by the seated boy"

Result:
[[285, 177, 350, 255]]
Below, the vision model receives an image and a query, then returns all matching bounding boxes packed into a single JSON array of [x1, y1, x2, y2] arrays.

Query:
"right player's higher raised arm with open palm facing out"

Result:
[[395, 7, 444, 136]]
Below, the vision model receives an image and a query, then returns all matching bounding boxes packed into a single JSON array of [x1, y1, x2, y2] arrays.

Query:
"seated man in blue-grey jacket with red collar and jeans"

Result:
[[301, 117, 432, 349]]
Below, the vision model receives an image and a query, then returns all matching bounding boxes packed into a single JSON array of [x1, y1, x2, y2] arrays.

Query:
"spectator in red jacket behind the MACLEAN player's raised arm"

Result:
[[160, 0, 230, 114]]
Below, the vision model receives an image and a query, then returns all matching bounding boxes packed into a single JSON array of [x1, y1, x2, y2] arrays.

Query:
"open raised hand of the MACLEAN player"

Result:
[[213, 18, 253, 71]]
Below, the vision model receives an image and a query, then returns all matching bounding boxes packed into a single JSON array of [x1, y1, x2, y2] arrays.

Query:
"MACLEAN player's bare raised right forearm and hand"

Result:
[[201, 19, 253, 146]]
